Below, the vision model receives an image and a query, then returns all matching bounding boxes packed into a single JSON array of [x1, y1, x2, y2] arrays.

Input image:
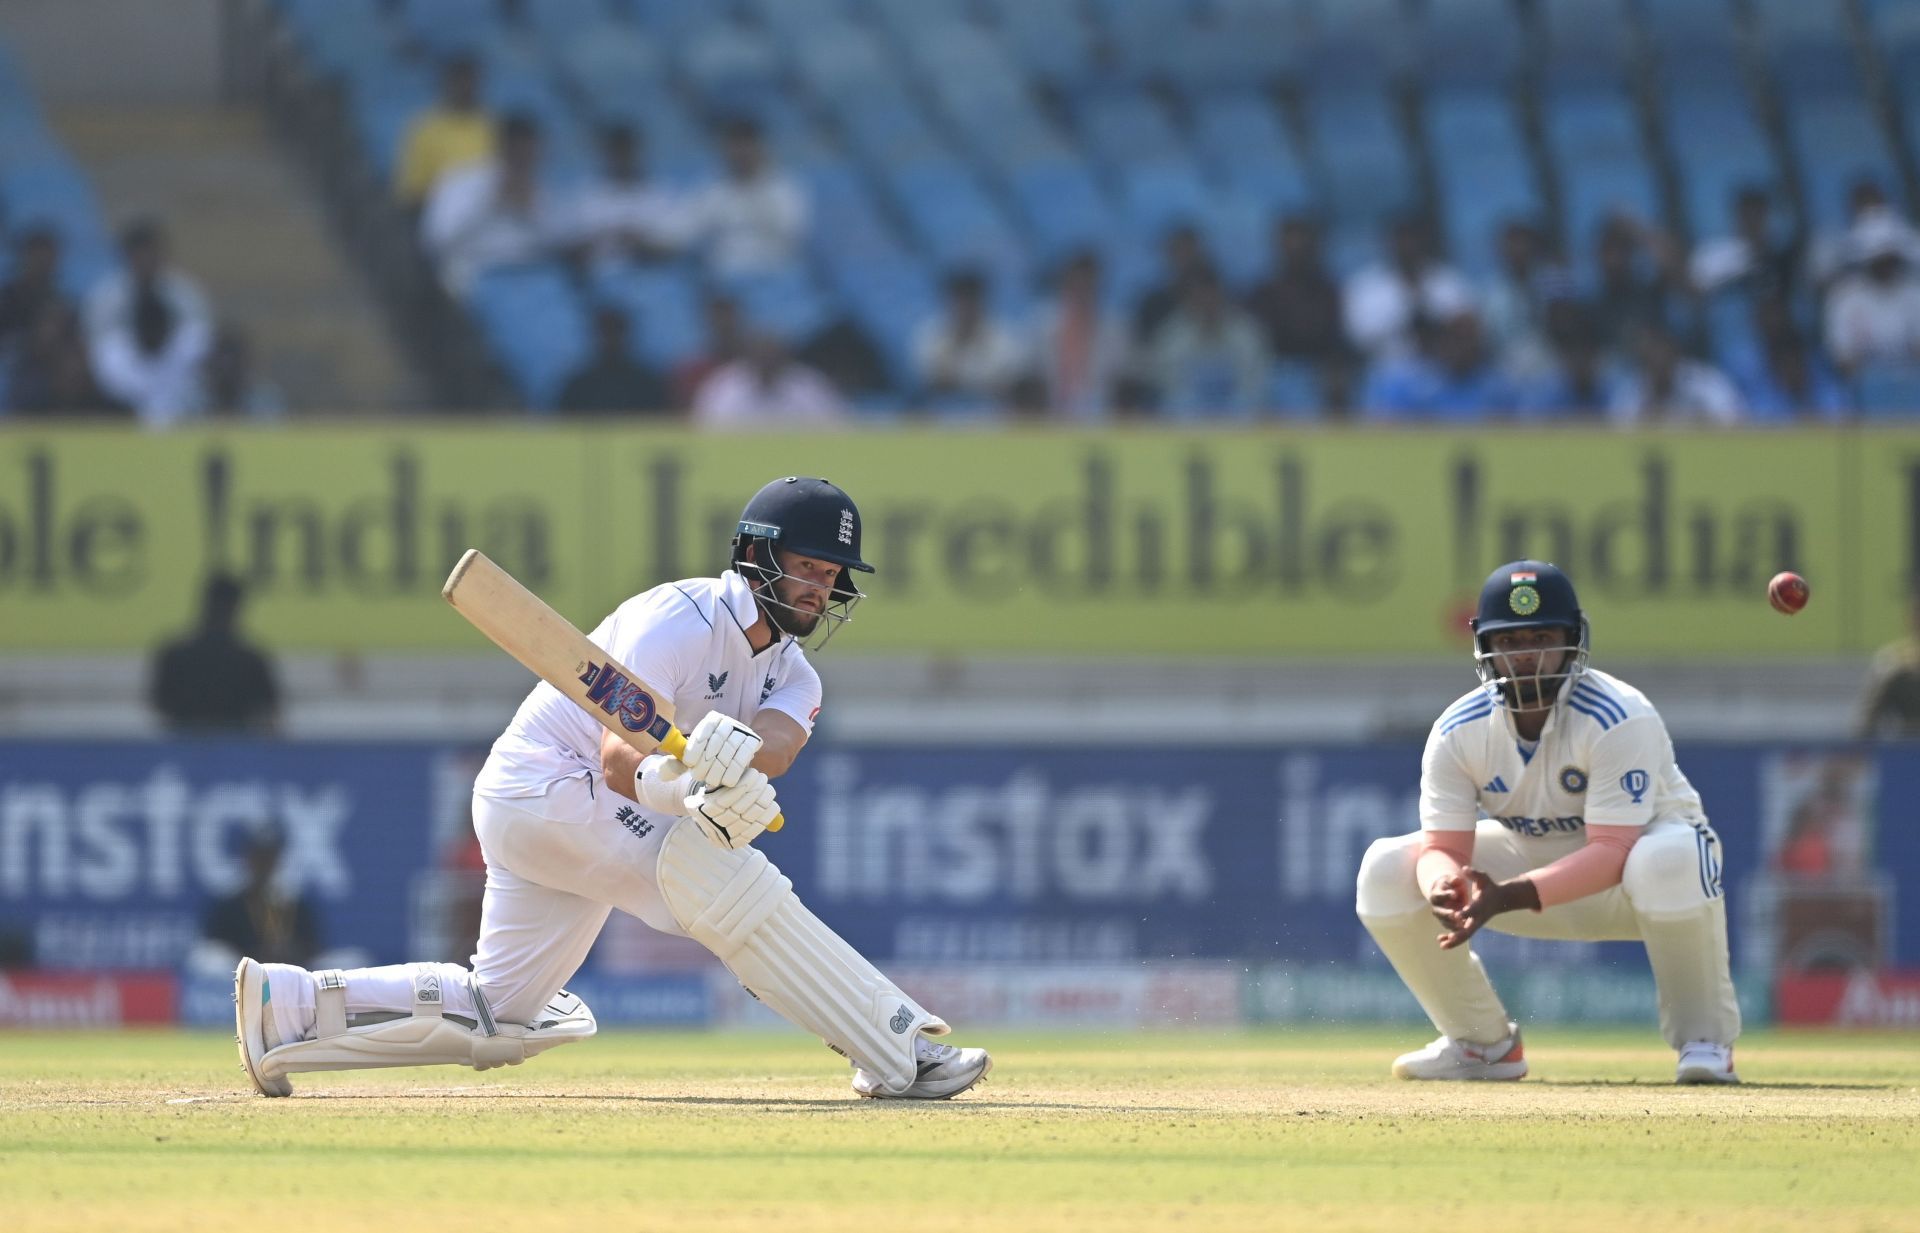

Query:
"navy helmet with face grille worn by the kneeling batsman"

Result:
[[732, 474, 874, 647]]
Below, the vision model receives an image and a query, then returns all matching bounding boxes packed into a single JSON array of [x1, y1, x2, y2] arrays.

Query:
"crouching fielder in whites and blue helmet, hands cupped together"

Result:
[[1357, 561, 1740, 1083]]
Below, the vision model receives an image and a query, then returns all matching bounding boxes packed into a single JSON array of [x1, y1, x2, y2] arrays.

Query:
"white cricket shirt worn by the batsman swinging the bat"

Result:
[[474, 570, 820, 797]]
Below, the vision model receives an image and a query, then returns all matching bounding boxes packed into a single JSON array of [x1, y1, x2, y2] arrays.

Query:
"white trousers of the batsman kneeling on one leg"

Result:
[[271, 772, 691, 1039]]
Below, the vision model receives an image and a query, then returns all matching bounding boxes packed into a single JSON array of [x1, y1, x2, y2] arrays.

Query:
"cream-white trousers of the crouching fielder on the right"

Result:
[[1356, 818, 1740, 1049]]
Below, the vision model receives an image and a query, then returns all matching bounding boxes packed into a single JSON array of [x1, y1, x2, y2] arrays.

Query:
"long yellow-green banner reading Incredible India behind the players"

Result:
[[0, 424, 1920, 657]]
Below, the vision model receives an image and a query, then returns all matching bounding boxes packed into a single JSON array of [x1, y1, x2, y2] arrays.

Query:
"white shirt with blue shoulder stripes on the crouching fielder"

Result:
[[1421, 668, 1705, 852]]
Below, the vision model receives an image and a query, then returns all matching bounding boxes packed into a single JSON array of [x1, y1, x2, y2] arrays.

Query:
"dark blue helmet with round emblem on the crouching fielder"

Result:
[[1471, 561, 1590, 711]]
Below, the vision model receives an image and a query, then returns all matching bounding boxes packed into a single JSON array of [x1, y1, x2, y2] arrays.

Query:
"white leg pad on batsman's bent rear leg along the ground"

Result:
[[259, 964, 597, 1079]]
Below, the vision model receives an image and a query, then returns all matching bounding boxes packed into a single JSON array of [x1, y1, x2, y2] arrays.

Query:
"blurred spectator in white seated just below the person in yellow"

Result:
[[420, 113, 563, 298]]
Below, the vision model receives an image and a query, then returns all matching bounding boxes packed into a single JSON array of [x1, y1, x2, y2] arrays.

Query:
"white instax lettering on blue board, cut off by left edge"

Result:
[[0, 764, 353, 903]]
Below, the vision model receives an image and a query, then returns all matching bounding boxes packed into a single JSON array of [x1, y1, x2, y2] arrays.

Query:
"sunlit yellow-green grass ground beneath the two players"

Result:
[[0, 1026, 1920, 1233]]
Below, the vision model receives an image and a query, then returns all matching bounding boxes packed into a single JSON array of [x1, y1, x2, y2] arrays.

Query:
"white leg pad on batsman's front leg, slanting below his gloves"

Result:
[[659, 826, 948, 1095]]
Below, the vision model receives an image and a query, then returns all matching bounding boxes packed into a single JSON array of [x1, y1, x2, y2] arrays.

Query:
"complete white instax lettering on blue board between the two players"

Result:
[[814, 755, 1213, 903]]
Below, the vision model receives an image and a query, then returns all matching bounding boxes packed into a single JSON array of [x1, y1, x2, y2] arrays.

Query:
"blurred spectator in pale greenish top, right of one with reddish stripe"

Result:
[[1148, 267, 1271, 419]]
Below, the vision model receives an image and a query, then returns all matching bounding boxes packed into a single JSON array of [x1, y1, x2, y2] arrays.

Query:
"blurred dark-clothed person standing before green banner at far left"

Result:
[[148, 574, 280, 734]]
